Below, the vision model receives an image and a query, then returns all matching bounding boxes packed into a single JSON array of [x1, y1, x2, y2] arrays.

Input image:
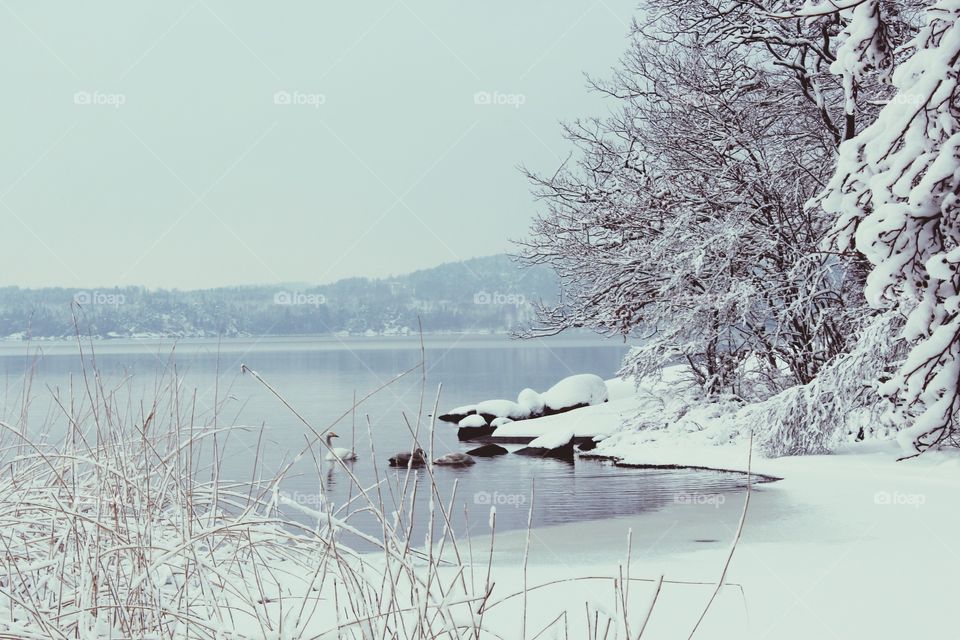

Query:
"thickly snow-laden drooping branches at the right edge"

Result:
[[816, 0, 960, 451]]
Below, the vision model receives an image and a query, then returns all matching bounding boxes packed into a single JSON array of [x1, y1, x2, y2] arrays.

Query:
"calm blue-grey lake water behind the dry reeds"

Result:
[[0, 336, 742, 544]]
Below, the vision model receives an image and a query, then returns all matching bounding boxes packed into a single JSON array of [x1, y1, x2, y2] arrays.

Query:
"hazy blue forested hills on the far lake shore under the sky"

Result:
[[0, 255, 557, 337]]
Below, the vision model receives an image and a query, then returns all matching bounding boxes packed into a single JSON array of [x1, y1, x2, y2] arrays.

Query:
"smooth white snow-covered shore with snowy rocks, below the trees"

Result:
[[480, 372, 960, 640]]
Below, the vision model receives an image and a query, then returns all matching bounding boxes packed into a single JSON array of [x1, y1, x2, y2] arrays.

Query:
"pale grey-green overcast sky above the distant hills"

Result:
[[0, 0, 635, 289]]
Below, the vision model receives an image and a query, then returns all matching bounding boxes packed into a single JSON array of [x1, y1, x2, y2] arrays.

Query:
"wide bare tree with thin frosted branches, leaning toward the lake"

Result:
[[523, 2, 872, 397]]
